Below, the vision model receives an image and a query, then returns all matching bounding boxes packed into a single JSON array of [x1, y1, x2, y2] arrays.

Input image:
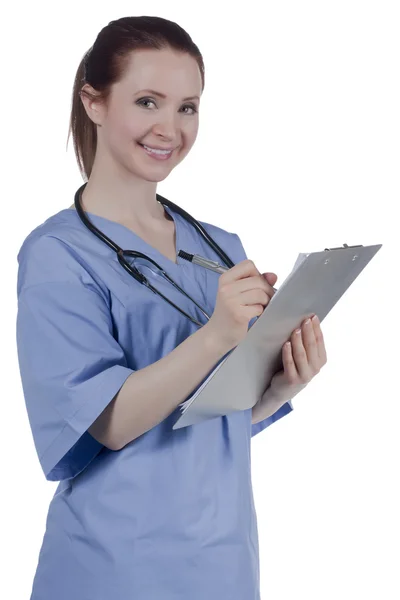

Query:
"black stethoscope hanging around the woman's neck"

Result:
[[75, 183, 235, 327]]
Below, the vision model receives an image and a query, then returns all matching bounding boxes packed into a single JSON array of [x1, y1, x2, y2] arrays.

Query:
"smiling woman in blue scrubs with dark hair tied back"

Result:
[[17, 17, 326, 600]]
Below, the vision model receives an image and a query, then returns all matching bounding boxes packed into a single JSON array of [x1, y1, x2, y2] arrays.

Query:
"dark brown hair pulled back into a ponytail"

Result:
[[67, 16, 204, 179]]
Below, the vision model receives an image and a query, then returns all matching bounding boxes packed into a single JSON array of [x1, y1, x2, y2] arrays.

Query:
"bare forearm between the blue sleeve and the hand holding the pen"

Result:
[[89, 325, 227, 450]]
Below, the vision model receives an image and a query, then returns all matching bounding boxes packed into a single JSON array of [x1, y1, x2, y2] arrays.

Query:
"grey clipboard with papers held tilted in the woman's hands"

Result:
[[173, 244, 382, 429]]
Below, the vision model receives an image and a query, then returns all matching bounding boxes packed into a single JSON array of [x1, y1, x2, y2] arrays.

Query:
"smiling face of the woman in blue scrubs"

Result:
[[85, 49, 202, 182]]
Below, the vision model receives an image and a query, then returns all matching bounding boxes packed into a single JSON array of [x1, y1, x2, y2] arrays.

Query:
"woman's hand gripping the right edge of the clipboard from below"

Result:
[[268, 315, 327, 400]]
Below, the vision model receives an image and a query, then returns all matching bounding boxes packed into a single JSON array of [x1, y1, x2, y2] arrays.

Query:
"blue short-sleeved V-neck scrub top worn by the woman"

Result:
[[17, 202, 292, 600]]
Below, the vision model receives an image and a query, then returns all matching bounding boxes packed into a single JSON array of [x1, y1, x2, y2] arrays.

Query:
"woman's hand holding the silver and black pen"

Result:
[[205, 259, 277, 352]]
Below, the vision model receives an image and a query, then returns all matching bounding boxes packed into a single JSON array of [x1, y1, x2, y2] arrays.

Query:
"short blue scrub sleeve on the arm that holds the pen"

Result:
[[16, 237, 134, 481]]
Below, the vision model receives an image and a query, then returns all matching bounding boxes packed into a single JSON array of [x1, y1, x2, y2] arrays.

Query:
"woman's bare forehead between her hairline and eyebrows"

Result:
[[120, 49, 202, 96]]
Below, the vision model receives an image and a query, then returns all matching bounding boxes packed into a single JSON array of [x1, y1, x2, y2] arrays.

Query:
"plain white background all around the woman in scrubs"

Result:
[[0, 0, 400, 600]]
